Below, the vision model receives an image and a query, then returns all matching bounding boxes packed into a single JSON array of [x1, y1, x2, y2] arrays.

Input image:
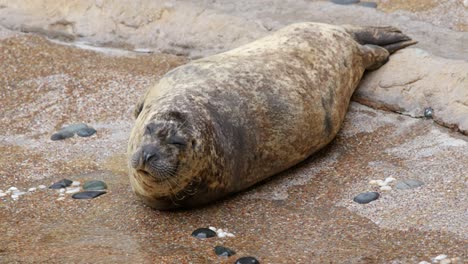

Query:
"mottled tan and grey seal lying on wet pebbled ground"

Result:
[[128, 23, 416, 210]]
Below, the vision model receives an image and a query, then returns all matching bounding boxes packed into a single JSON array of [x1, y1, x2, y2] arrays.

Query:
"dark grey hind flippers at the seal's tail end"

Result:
[[343, 25, 418, 54]]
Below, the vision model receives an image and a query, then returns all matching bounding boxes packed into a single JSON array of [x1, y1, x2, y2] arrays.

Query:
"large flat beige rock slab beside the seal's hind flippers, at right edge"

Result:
[[353, 48, 468, 135]]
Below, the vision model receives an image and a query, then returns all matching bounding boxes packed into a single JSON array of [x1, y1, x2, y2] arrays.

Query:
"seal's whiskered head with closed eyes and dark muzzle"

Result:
[[128, 111, 208, 210]]
